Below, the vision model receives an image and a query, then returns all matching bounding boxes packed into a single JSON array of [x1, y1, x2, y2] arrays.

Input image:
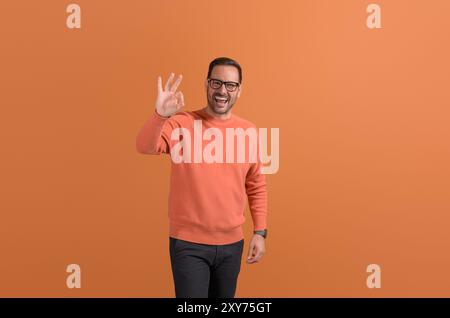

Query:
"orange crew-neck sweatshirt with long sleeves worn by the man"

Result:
[[136, 108, 267, 245]]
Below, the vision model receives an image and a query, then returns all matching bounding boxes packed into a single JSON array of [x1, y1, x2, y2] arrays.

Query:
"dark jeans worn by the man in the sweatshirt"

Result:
[[169, 237, 244, 298]]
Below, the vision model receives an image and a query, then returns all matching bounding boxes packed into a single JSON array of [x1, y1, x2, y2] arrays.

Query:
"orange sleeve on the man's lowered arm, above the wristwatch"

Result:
[[245, 161, 267, 231]]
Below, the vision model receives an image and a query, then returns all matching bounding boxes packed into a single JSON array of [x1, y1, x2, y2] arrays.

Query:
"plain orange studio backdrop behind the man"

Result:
[[0, 0, 450, 297]]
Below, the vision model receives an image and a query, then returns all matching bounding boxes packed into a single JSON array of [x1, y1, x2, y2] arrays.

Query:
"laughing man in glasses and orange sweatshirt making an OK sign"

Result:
[[136, 57, 267, 298]]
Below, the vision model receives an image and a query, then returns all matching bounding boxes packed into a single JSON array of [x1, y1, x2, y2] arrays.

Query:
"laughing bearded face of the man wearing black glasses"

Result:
[[205, 65, 241, 115]]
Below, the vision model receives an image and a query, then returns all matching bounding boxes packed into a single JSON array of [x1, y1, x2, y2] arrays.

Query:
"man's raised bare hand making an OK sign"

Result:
[[156, 73, 184, 117]]
